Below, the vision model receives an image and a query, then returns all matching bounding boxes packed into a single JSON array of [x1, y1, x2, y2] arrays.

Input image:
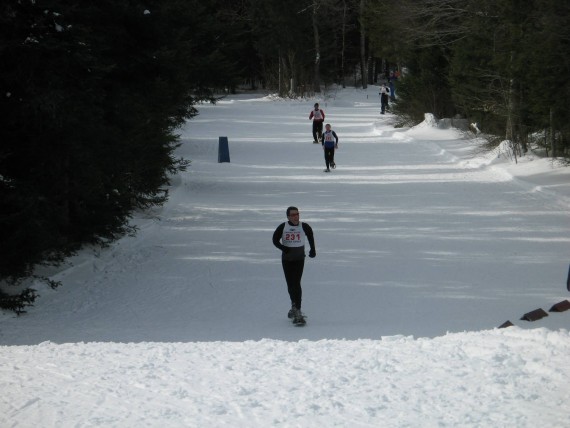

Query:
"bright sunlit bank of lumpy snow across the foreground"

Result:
[[0, 328, 570, 427]]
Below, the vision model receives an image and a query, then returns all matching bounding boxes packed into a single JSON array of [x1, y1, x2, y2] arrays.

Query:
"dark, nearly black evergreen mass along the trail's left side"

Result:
[[0, 0, 244, 306]]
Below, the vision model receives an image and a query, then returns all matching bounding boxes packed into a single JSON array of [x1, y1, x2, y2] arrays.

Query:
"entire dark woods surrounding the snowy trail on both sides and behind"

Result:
[[0, 0, 570, 311]]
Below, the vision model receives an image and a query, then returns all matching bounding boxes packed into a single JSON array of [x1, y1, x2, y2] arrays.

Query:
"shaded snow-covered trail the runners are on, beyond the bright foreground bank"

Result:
[[0, 89, 570, 344]]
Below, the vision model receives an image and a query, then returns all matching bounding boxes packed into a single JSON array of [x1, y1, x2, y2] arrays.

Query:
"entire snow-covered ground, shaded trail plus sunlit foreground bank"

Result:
[[0, 86, 570, 427]]
